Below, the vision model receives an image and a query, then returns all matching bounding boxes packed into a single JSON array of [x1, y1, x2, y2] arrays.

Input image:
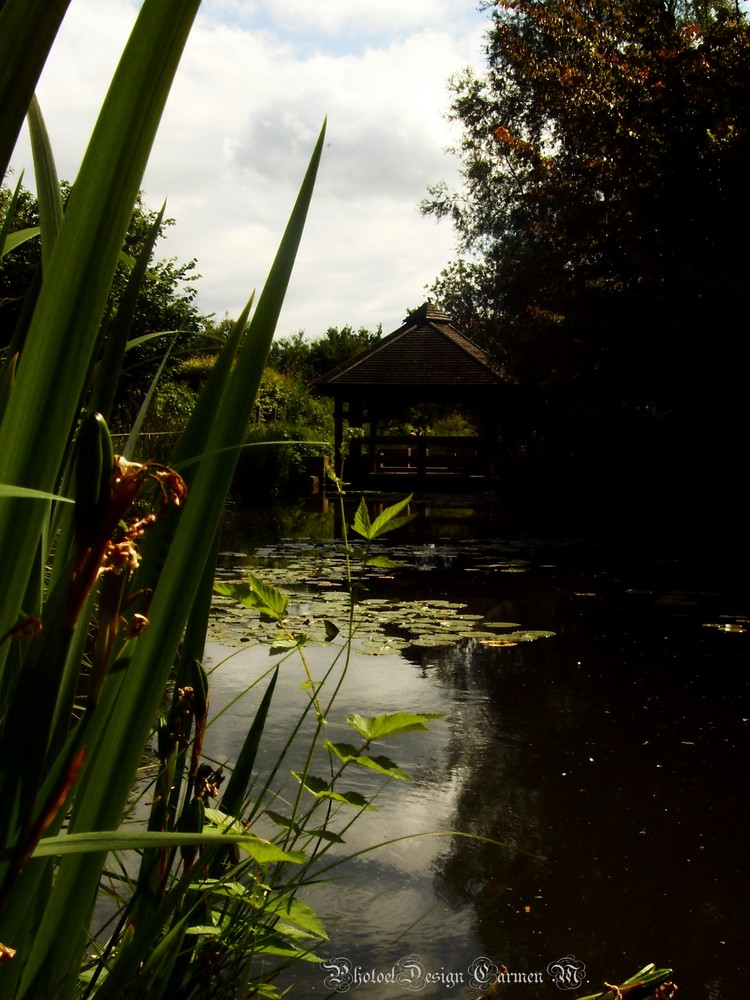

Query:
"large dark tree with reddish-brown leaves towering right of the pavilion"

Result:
[[423, 0, 750, 528]]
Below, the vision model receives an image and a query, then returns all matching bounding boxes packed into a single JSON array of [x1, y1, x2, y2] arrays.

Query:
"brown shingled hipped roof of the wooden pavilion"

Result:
[[316, 303, 508, 394]]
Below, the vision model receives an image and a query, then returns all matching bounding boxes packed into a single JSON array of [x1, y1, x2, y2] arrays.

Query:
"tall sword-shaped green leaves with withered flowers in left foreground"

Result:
[[0, 0, 324, 1000]]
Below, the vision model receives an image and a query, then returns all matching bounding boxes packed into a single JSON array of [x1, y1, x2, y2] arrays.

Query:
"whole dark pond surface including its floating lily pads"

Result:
[[206, 500, 750, 1000]]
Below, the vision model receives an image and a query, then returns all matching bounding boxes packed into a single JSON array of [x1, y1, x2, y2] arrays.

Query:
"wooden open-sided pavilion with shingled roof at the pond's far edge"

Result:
[[316, 304, 511, 490]]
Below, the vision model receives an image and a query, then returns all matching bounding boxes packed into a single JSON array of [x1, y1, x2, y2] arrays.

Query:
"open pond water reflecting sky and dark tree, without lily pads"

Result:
[[211, 504, 750, 1000]]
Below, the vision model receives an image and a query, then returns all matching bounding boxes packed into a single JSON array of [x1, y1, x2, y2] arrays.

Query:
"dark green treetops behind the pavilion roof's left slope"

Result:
[[268, 325, 382, 384]]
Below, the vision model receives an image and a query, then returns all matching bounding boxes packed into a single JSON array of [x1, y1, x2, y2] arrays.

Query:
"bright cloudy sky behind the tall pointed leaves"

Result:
[[14, 0, 487, 335]]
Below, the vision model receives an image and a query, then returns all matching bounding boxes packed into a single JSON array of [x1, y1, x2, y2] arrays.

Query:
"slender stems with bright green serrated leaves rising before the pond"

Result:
[[206, 488, 442, 988]]
